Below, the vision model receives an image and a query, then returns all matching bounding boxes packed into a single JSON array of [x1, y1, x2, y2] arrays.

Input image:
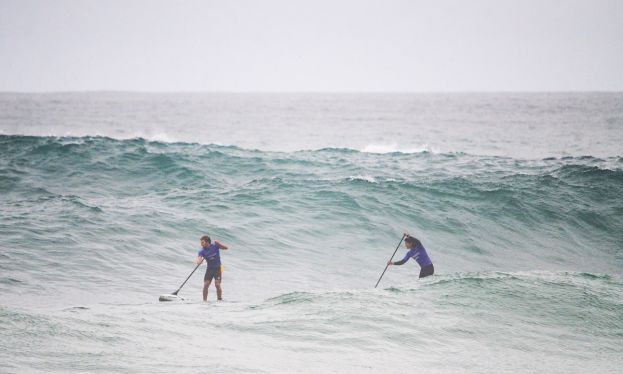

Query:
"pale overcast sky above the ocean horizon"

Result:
[[0, 0, 623, 92]]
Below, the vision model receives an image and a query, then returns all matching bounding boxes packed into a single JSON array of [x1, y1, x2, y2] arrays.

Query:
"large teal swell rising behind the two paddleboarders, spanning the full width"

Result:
[[0, 136, 623, 290]]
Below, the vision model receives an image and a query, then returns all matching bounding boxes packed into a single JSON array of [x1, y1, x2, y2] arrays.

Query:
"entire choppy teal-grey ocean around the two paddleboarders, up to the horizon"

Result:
[[0, 92, 623, 374]]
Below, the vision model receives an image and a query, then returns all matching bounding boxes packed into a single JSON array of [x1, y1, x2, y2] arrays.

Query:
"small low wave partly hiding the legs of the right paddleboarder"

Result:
[[249, 271, 623, 329]]
